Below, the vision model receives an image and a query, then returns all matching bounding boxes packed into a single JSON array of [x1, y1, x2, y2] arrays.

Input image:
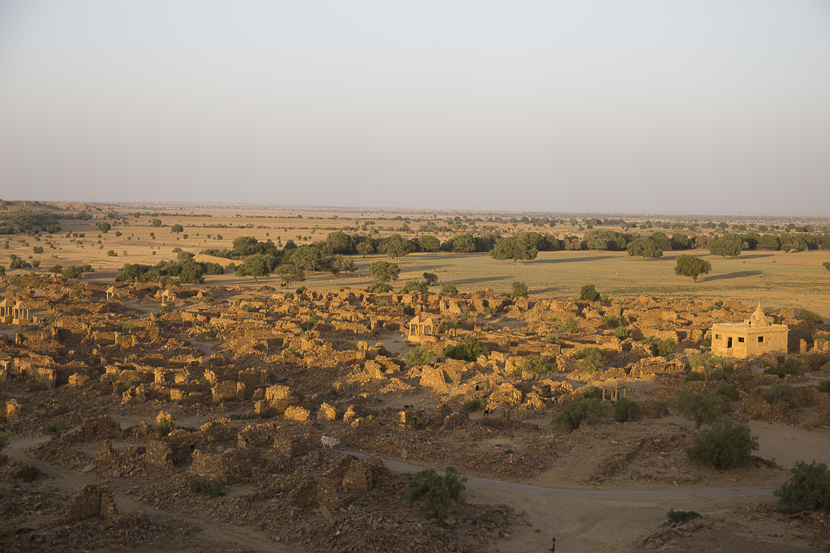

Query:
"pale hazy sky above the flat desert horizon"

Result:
[[0, 0, 830, 215]]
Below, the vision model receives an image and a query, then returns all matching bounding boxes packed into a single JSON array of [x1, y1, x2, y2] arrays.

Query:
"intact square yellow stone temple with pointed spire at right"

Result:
[[712, 303, 790, 359]]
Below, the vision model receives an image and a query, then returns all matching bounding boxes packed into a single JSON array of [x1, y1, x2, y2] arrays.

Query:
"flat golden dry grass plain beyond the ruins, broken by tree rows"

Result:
[[0, 206, 830, 317]]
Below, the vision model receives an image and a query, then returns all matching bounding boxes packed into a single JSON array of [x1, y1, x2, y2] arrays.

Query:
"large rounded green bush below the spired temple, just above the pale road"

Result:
[[686, 419, 758, 469]]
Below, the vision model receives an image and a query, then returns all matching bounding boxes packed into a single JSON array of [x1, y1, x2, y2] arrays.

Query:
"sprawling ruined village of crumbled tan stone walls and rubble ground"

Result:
[[0, 268, 830, 552]]
